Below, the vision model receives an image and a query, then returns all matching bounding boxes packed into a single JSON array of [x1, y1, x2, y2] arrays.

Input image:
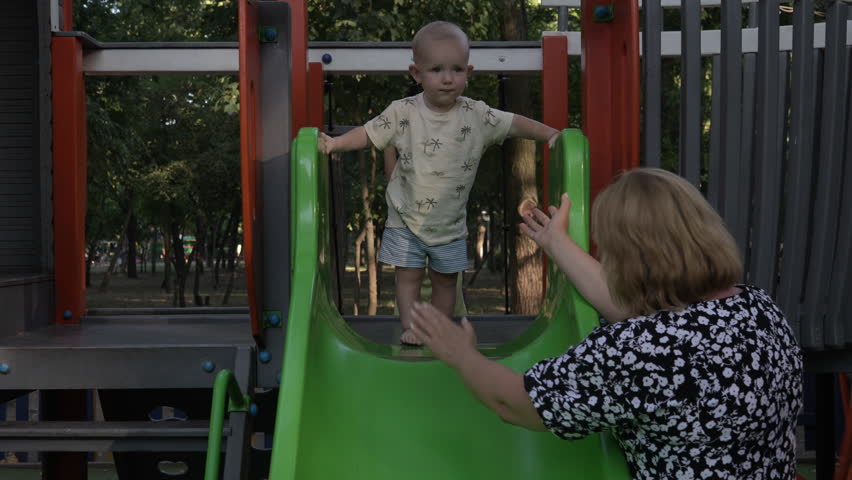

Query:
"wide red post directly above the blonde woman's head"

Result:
[[581, 0, 639, 202]]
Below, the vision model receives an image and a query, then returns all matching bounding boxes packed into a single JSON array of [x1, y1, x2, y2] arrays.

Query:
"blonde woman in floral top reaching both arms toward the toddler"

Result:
[[413, 168, 802, 479]]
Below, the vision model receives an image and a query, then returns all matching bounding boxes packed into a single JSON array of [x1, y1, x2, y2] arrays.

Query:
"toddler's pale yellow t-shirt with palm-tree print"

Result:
[[364, 93, 514, 246]]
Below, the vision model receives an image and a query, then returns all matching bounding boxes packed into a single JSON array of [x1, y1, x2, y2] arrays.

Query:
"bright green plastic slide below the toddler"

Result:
[[269, 128, 630, 480]]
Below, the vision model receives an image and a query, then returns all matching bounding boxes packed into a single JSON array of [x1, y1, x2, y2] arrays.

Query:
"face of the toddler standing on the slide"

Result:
[[408, 38, 473, 112]]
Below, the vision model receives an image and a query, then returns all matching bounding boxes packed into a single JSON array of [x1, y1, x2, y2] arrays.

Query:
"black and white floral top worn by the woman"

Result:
[[524, 286, 802, 480]]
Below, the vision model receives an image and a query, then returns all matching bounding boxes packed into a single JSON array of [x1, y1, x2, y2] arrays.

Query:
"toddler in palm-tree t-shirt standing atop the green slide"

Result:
[[318, 22, 558, 345]]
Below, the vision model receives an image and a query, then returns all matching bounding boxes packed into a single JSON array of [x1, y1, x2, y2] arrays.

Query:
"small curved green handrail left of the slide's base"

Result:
[[204, 370, 251, 480]]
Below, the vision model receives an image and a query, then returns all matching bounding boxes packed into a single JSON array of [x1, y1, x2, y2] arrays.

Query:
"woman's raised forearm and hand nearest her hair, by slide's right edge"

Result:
[[520, 193, 629, 323]]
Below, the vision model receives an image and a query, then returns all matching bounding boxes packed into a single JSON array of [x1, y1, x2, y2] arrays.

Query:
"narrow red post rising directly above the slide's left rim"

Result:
[[283, 0, 309, 138]]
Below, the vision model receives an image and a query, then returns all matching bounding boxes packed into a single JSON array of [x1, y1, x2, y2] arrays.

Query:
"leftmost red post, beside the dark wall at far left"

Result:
[[51, 35, 86, 323]]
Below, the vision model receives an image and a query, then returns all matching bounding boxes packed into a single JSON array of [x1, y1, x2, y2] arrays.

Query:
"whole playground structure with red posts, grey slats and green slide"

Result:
[[0, 0, 852, 479]]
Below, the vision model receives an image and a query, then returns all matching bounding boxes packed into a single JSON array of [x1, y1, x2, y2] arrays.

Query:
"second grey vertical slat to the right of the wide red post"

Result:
[[679, 3, 704, 187]]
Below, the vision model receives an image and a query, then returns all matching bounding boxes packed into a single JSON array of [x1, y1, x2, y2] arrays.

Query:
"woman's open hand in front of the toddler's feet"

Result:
[[411, 303, 477, 368]]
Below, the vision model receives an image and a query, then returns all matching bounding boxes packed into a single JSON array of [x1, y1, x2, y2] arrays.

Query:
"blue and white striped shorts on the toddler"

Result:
[[379, 227, 467, 273]]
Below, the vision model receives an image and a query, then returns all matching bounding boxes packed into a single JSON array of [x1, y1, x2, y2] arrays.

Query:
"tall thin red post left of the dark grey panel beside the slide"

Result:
[[238, 0, 263, 336]]
